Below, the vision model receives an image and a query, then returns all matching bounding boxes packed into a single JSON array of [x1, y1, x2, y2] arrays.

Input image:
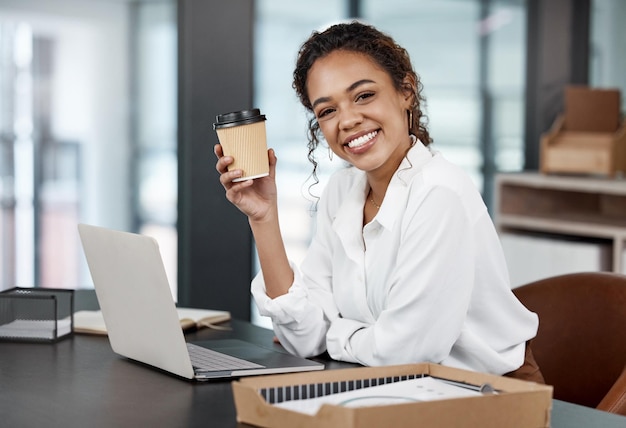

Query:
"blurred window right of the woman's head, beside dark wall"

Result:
[[362, 0, 526, 205]]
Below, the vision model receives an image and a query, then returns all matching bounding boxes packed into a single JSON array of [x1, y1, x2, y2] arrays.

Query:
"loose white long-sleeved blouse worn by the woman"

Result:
[[252, 141, 538, 374]]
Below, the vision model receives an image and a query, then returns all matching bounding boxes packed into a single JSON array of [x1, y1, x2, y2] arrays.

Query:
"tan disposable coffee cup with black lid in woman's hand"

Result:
[[213, 109, 270, 181]]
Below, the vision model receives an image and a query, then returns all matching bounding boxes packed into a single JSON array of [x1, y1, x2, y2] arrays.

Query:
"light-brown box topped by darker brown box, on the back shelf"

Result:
[[540, 86, 626, 177]]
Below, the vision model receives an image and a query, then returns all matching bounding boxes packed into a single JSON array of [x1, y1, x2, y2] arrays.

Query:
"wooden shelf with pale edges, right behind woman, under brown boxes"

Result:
[[495, 172, 626, 272]]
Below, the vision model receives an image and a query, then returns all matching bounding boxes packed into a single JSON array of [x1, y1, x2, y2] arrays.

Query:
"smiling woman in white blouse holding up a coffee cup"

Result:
[[215, 22, 541, 380]]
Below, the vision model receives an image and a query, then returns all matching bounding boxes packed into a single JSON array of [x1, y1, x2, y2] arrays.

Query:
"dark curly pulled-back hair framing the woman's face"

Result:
[[292, 21, 432, 178]]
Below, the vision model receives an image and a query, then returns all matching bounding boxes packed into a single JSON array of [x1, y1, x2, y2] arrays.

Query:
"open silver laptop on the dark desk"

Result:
[[78, 224, 324, 380]]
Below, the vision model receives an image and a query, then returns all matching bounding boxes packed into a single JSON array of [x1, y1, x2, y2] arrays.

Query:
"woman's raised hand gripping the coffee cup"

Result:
[[214, 144, 277, 222]]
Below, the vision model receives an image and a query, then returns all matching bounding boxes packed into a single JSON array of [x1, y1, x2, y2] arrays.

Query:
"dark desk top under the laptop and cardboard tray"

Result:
[[0, 320, 626, 428]]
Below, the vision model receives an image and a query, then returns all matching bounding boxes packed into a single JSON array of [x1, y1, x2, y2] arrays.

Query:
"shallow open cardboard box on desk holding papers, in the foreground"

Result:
[[232, 363, 552, 428]]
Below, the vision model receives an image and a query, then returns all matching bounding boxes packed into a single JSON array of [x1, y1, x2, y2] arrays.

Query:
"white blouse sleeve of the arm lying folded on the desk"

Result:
[[327, 187, 475, 366]]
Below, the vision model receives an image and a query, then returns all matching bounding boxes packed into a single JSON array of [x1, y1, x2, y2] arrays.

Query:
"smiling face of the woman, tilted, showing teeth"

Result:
[[307, 50, 411, 177]]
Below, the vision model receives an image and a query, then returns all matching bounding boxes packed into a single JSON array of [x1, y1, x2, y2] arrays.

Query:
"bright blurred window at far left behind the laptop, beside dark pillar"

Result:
[[0, 0, 177, 295]]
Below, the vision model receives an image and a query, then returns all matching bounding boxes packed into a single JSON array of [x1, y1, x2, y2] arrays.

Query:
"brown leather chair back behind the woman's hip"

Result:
[[513, 272, 626, 415]]
